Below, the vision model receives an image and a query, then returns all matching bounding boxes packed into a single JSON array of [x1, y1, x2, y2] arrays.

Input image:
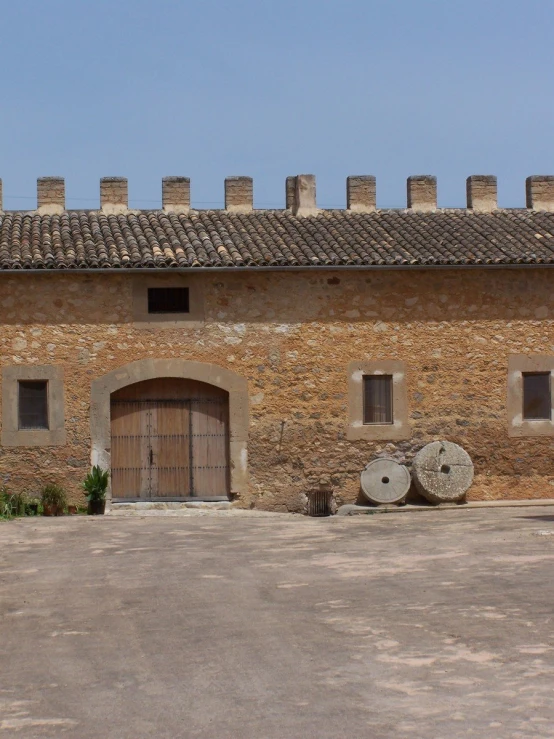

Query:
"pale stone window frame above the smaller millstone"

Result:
[[346, 359, 411, 441]]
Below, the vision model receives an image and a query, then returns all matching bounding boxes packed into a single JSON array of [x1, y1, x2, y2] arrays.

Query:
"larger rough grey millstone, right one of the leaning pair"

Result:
[[412, 441, 473, 503]]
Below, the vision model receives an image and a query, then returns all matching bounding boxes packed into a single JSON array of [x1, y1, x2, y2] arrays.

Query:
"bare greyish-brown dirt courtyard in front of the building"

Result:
[[0, 507, 554, 739]]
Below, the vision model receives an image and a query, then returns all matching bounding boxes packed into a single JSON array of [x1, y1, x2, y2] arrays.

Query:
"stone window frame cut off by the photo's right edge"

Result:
[[507, 354, 554, 437]]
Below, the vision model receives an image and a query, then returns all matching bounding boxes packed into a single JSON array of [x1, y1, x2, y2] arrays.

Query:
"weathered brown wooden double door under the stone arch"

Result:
[[111, 378, 229, 500]]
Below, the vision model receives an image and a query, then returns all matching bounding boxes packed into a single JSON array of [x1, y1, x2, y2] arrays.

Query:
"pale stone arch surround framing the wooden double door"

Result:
[[90, 359, 248, 497]]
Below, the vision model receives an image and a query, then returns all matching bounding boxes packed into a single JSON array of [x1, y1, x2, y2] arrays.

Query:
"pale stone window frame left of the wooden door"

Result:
[[1, 365, 66, 447]]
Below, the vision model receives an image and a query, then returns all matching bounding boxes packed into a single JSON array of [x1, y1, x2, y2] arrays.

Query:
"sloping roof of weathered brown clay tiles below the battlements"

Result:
[[0, 209, 554, 269]]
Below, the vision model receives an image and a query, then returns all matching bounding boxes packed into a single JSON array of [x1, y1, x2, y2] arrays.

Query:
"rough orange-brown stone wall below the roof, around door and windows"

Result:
[[0, 269, 554, 511]]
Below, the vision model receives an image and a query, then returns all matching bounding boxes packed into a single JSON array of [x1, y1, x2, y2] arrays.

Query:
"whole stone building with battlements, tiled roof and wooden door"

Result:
[[0, 175, 554, 511]]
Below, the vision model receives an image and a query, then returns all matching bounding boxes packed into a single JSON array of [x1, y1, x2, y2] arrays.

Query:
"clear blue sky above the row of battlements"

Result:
[[0, 0, 554, 209]]
